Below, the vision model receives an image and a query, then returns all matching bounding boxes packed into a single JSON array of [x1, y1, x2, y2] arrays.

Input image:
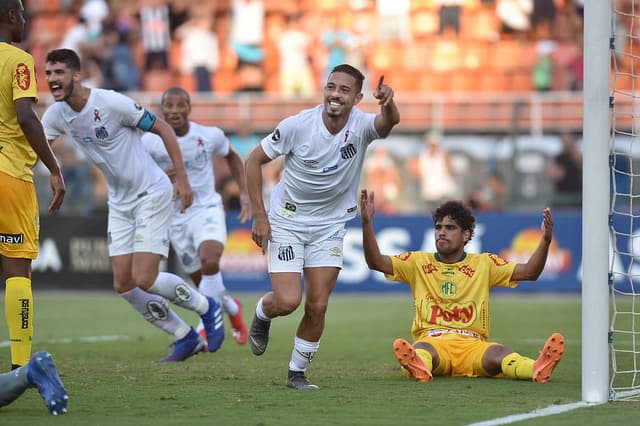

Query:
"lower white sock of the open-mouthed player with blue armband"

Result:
[[120, 287, 191, 339]]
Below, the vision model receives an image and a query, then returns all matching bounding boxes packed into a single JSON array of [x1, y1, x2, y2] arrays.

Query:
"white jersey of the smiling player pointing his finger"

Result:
[[261, 105, 380, 227]]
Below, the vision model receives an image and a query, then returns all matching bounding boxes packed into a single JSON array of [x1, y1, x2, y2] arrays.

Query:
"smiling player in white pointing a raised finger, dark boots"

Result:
[[246, 64, 400, 389]]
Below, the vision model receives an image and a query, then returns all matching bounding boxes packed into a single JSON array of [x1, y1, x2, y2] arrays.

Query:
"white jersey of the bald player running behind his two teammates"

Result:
[[142, 121, 229, 216]]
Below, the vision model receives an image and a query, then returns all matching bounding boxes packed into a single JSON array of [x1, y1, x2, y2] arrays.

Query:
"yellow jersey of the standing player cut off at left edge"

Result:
[[0, 42, 38, 182]]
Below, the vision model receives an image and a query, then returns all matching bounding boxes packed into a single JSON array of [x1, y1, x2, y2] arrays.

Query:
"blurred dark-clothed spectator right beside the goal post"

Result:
[[547, 132, 582, 208]]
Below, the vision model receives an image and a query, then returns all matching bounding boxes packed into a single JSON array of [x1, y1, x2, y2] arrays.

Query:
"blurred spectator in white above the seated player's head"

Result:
[[407, 131, 461, 211]]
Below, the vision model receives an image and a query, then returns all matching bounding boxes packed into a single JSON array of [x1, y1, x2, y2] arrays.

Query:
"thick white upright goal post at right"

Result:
[[582, 0, 615, 403]]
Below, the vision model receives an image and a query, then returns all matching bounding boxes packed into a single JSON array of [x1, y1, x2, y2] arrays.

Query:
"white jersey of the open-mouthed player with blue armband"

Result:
[[42, 89, 171, 208]]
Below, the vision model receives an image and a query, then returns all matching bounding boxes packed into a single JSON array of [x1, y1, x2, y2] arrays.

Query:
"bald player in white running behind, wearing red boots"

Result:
[[142, 87, 251, 345]]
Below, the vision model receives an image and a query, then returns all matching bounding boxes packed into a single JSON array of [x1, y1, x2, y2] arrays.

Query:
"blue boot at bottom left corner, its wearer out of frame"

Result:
[[27, 351, 69, 416]]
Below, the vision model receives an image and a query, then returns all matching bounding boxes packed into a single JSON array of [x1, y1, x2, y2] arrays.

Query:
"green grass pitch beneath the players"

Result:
[[0, 291, 640, 426]]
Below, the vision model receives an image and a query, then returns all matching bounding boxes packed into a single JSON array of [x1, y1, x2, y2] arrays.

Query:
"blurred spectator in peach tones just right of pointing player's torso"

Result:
[[362, 146, 403, 214]]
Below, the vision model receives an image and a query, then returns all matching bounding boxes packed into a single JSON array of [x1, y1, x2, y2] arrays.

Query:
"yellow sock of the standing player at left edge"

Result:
[[4, 277, 33, 365]]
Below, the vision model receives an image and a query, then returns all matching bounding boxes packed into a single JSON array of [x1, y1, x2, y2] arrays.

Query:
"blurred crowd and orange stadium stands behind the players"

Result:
[[23, 0, 608, 218]]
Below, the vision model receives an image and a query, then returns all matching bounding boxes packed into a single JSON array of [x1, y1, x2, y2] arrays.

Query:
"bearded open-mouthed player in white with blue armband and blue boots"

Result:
[[42, 49, 224, 362]]
